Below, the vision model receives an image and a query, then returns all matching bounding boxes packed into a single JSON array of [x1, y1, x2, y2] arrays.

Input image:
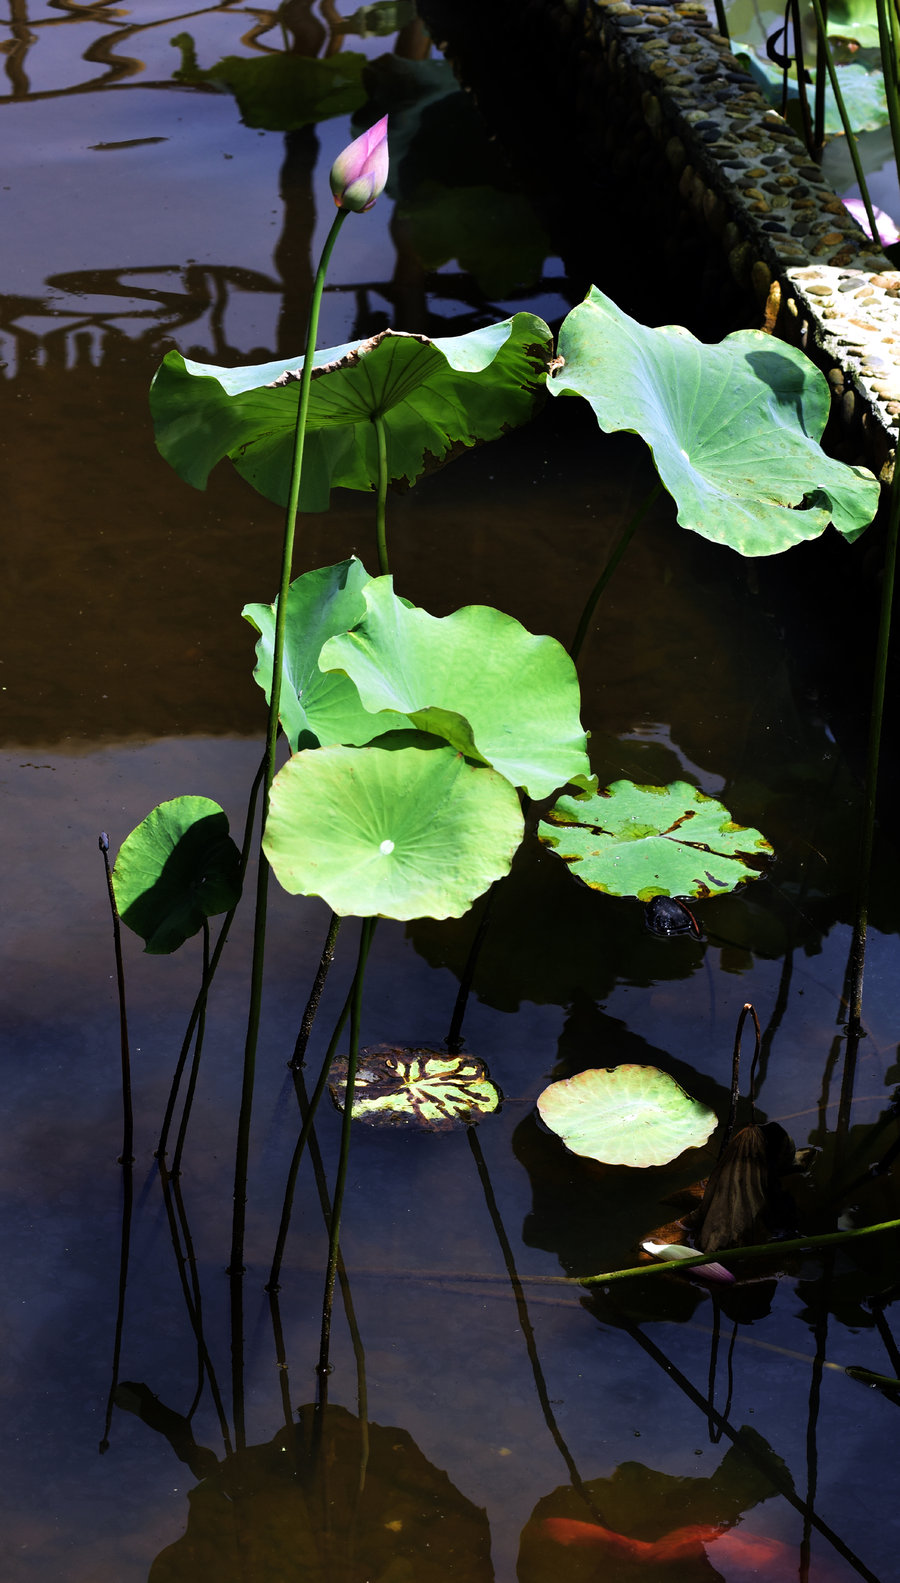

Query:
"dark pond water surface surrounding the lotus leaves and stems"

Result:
[[0, 0, 900, 1583]]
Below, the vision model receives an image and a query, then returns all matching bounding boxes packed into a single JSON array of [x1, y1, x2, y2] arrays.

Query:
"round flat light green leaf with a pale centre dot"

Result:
[[263, 731, 524, 918]]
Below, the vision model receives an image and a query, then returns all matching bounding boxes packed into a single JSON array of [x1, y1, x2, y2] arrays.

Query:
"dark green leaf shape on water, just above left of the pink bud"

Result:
[[172, 33, 369, 131]]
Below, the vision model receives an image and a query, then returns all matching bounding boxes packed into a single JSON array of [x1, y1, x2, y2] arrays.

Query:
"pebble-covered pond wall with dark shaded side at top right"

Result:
[[421, 0, 900, 478]]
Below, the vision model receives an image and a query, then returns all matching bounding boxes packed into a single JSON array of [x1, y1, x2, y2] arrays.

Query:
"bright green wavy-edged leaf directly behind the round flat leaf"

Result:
[[320, 578, 590, 798]]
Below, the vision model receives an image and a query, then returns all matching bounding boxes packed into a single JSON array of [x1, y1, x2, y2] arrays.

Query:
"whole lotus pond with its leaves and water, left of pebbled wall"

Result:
[[0, 0, 900, 1583]]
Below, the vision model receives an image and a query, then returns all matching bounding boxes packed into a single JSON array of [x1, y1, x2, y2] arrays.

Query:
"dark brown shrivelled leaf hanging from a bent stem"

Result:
[[685, 1121, 794, 1254]]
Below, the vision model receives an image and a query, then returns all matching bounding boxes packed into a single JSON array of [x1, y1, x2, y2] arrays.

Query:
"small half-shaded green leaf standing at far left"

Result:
[[112, 796, 240, 956]]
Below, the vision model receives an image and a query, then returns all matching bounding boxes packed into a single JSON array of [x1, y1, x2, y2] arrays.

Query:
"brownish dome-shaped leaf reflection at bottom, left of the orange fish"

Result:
[[149, 1406, 493, 1583]]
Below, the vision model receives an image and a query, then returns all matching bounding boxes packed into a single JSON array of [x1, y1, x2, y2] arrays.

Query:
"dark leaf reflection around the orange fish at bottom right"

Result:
[[517, 1428, 789, 1583]]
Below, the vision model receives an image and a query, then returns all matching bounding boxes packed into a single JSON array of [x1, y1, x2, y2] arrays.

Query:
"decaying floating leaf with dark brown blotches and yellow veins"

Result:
[[329, 1045, 500, 1132]]
